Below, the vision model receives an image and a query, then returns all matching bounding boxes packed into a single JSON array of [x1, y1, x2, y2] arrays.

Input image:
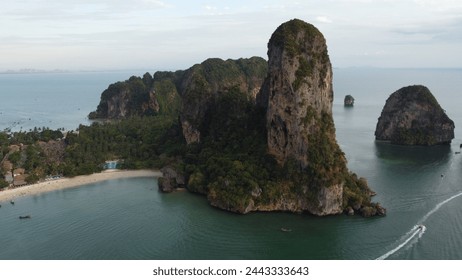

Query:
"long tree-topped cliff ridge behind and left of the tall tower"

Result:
[[89, 57, 268, 144]]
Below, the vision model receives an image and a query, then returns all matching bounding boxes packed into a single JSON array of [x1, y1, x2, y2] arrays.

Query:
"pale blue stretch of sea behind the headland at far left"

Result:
[[0, 71, 146, 131]]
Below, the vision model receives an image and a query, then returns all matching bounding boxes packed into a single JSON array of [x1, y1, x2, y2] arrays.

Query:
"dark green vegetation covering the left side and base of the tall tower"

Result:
[[181, 86, 376, 213]]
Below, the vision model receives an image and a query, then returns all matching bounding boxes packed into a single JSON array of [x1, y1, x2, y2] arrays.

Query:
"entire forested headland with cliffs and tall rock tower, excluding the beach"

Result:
[[0, 19, 385, 216]]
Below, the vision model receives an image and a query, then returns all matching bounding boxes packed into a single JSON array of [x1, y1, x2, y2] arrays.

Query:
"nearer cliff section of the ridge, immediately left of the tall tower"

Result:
[[180, 57, 267, 144]]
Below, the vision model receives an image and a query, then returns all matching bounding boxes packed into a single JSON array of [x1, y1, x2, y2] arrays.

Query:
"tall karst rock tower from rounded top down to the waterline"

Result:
[[257, 19, 348, 215]]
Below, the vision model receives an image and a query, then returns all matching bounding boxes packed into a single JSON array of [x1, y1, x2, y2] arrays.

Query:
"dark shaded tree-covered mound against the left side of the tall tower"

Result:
[[185, 90, 281, 213]]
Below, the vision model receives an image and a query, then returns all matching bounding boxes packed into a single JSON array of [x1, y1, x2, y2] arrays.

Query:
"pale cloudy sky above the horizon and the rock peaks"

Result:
[[0, 0, 462, 71]]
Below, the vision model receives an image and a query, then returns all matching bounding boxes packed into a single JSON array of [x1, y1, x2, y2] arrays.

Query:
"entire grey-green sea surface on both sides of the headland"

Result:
[[0, 68, 462, 260]]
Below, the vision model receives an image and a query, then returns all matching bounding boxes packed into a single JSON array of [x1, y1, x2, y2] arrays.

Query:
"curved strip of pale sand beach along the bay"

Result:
[[0, 170, 162, 201]]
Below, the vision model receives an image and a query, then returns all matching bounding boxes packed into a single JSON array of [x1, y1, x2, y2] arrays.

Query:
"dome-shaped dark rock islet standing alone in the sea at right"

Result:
[[375, 85, 454, 146]]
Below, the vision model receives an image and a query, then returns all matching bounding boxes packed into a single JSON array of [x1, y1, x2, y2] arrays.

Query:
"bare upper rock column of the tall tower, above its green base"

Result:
[[266, 20, 333, 167]]
